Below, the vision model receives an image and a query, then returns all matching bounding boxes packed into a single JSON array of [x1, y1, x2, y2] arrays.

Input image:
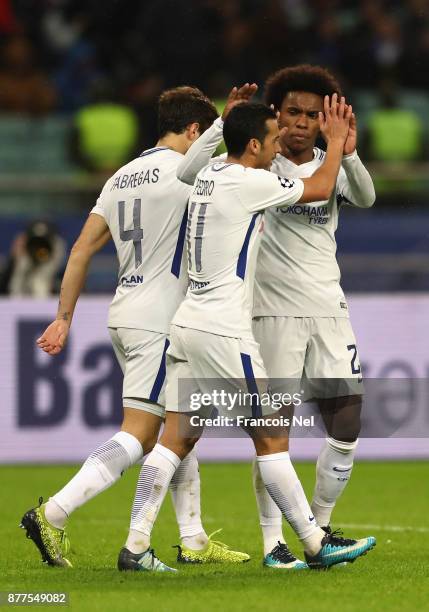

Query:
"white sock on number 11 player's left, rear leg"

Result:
[[125, 443, 180, 554]]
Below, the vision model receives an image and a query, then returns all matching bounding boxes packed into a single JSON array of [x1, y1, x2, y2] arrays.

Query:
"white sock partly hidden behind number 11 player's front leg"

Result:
[[253, 458, 285, 557]]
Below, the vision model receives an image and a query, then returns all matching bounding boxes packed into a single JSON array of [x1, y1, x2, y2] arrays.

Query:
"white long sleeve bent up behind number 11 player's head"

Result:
[[177, 117, 226, 185]]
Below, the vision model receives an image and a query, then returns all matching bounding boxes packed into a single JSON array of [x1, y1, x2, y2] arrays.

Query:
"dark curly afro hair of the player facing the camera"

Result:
[[265, 64, 342, 110]]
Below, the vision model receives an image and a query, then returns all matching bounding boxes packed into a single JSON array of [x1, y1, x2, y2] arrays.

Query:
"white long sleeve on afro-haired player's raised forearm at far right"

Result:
[[337, 151, 375, 208]]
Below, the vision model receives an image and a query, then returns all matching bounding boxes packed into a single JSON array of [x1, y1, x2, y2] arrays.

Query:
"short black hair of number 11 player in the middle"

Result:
[[223, 104, 277, 155]]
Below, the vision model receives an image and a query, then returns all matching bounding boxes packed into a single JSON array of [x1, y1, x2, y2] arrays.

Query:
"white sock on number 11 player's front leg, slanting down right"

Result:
[[256, 452, 325, 555]]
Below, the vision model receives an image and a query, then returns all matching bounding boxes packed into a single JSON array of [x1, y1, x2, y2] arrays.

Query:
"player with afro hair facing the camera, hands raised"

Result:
[[174, 65, 375, 567]]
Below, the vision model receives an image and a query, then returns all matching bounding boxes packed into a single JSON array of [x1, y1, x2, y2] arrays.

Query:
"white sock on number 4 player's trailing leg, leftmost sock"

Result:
[[45, 431, 143, 528]]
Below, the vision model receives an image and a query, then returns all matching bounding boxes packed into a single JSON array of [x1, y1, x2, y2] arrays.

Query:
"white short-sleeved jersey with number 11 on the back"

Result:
[[172, 162, 304, 338]]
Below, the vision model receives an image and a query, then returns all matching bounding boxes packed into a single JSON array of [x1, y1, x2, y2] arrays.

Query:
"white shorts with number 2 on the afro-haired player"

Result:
[[253, 317, 363, 399]]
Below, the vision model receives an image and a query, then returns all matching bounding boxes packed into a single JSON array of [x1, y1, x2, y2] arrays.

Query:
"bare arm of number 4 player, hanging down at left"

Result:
[[37, 214, 111, 355]]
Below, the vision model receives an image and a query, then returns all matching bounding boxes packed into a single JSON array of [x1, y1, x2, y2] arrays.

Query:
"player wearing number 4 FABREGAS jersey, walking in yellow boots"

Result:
[[22, 85, 255, 571]]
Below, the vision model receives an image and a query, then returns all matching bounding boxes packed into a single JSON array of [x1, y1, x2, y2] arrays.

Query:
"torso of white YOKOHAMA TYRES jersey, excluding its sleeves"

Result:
[[253, 148, 349, 317]]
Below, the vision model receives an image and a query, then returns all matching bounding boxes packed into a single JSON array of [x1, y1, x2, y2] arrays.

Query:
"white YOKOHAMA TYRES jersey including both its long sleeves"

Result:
[[178, 123, 375, 317]]
